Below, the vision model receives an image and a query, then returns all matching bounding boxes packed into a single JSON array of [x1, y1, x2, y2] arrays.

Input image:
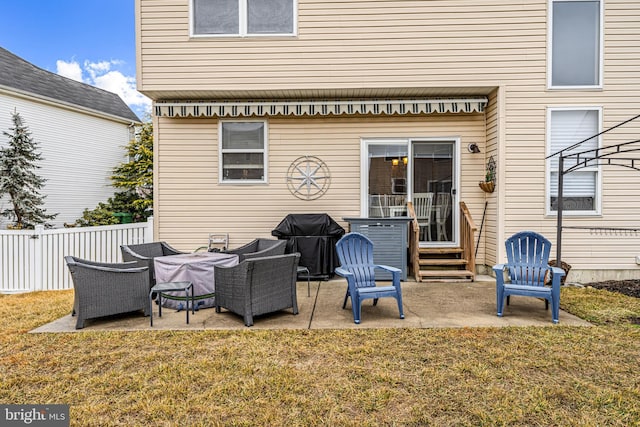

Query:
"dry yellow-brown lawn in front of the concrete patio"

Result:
[[0, 288, 640, 426]]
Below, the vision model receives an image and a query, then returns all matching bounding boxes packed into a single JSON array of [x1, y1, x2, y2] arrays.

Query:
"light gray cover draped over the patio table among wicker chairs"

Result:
[[154, 252, 238, 309]]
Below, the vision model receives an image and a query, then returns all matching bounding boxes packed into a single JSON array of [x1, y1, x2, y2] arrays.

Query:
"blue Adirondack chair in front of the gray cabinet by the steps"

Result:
[[336, 233, 404, 324]]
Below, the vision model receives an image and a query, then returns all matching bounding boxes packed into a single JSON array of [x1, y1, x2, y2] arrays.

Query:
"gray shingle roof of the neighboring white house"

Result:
[[0, 47, 140, 122]]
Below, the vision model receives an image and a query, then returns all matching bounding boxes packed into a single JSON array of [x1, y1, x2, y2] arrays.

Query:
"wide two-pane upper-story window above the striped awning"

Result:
[[191, 0, 296, 36]]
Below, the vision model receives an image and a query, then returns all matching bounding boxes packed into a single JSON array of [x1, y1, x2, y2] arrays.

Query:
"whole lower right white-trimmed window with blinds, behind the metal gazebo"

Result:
[[547, 108, 600, 214]]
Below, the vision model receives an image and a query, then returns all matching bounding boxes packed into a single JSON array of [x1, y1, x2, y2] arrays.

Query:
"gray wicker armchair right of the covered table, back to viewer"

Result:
[[214, 253, 300, 326]]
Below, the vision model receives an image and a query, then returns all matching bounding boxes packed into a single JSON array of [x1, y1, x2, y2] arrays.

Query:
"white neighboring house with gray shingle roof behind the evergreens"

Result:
[[0, 48, 140, 227]]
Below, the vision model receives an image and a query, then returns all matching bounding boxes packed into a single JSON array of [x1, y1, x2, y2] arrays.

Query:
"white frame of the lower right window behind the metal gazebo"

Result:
[[544, 106, 602, 217]]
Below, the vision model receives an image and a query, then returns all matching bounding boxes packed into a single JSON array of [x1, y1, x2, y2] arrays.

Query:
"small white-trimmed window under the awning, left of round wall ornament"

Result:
[[219, 121, 267, 183]]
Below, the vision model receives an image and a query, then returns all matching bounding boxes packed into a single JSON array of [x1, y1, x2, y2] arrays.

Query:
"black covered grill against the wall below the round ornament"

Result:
[[271, 214, 345, 280]]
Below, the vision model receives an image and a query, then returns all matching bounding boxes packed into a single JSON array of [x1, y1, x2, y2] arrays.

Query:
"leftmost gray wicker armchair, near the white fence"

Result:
[[64, 256, 150, 329]]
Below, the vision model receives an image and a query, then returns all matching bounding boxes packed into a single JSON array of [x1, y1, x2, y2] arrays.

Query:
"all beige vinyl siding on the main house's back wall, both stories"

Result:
[[137, 0, 640, 281]]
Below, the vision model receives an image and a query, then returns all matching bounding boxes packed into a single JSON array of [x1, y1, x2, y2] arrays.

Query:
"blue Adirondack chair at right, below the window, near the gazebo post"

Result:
[[493, 231, 565, 323]]
